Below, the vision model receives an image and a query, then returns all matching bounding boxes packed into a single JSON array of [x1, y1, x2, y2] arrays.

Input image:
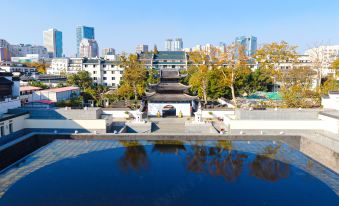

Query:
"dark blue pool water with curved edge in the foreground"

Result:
[[0, 142, 339, 206]]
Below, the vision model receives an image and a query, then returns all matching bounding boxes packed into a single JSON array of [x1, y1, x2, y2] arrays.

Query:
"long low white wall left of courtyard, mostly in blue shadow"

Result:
[[24, 119, 106, 130]]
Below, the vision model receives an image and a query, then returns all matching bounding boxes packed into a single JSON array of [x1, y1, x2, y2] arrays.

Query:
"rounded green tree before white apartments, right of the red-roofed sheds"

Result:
[[67, 71, 93, 90]]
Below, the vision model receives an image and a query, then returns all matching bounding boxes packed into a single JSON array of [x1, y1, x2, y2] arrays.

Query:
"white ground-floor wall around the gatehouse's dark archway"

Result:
[[147, 103, 191, 116]]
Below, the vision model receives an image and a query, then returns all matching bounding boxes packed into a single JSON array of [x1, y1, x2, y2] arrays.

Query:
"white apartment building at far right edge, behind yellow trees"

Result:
[[305, 45, 339, 76]]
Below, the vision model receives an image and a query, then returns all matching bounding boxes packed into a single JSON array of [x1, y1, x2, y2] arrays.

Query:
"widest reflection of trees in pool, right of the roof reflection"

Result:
[[186, 140, 247, 181]]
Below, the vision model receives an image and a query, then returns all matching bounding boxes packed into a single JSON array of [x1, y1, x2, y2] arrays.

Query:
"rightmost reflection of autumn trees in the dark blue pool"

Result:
[[250, 144, 290, 182]]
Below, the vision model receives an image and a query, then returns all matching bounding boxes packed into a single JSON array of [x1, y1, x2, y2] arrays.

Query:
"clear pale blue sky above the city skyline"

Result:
[[0, 0, 339, 55]]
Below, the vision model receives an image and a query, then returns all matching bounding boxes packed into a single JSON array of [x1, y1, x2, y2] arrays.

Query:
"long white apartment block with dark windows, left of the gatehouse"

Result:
[[47, 58, 124, 87]]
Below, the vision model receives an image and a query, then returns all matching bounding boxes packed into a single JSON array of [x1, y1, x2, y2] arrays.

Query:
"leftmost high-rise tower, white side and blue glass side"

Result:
[[44, 28, 63, 58]]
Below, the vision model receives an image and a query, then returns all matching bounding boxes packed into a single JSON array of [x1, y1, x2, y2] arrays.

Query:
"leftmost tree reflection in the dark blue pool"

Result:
[[119, 141, 149, 171]]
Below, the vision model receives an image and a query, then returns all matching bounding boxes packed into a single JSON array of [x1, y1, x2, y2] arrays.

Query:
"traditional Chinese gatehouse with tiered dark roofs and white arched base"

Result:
[[144, 69, 198, 117]]
